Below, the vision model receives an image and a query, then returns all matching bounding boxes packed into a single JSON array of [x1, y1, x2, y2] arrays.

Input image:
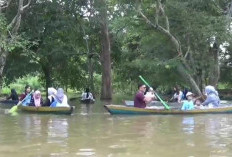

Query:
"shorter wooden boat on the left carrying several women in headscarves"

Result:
[[19, 106, 75, 114]]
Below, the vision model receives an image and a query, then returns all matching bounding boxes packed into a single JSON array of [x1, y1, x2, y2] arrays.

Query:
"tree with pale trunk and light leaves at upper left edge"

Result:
[[0, 0, 31, 91]]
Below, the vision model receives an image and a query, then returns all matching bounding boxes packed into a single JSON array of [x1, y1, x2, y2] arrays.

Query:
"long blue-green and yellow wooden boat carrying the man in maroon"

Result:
[[104, 105, 232, 115]]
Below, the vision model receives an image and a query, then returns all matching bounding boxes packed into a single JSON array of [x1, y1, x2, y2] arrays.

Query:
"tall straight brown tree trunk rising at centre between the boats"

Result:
[[99, 0, 112, 99]]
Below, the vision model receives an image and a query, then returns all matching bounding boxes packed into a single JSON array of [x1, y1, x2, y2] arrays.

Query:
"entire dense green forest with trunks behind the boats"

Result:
[[0, 0, 232, 99]]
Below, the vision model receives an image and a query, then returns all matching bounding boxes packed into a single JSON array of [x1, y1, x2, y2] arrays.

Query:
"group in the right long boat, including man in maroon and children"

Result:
[[134, 84, 220, 110]]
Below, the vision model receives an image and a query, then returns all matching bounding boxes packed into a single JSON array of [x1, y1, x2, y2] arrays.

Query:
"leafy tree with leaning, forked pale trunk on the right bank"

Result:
[[111, 0, 228, 95]]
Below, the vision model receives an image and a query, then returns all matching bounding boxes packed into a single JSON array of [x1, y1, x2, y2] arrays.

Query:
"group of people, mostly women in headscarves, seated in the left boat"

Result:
[[7, 85, 69, 107]]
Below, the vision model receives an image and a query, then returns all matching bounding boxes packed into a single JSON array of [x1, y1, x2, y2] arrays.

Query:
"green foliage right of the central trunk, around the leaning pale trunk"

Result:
[[111, 0, 230, 91]]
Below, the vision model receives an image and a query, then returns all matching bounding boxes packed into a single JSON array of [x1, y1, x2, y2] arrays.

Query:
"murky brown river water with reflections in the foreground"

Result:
[[0, 102, 232, 157]]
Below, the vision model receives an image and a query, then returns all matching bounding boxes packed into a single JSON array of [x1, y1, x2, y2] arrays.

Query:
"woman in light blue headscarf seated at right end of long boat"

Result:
[[202, 85, 220, 108]]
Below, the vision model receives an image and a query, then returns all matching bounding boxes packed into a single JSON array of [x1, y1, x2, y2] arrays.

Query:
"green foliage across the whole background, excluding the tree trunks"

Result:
[[0, 0, 232, 94]]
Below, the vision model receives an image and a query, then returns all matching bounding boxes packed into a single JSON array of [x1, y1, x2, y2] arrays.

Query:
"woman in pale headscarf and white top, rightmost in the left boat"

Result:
[[50, 88, 70, 107]]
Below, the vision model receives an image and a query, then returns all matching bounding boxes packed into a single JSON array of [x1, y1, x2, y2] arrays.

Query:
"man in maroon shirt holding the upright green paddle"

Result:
[[134, 84, 152, 108]]
